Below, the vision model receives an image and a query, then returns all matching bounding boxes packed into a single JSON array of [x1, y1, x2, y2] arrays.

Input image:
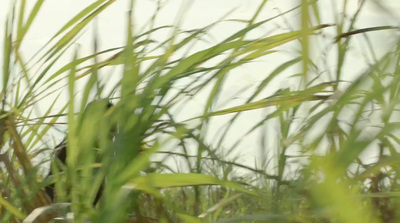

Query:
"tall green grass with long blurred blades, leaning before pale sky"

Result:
[[0, 0, 400, 223]]
